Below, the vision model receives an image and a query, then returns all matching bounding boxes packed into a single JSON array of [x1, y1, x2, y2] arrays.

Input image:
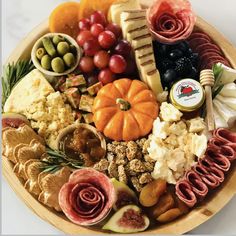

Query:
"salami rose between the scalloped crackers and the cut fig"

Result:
[[59, 168, 115, 225]]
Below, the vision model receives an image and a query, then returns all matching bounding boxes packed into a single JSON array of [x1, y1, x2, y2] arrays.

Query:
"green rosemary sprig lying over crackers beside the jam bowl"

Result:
[[41, 148, 84, 173]]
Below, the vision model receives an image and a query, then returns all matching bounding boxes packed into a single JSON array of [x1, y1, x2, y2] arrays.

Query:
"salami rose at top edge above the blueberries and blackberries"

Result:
[[147, 0, 196, 44]]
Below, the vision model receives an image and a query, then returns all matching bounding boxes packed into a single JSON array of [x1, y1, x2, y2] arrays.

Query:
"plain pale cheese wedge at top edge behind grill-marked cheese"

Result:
[[109, 0, 141, 25]]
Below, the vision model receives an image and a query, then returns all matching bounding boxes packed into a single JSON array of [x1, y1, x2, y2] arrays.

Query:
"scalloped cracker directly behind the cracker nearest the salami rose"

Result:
[[25, 159, 44, 196]]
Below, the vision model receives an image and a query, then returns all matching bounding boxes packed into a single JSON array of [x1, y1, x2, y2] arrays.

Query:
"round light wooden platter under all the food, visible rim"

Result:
[[2, 0, 236, 234]]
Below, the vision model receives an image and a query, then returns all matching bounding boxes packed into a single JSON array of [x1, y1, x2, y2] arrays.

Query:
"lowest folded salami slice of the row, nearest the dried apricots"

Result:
[[175, 180, 197, 207]]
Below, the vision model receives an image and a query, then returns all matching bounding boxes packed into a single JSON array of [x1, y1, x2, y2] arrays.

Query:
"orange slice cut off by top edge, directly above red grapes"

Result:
[[79, 0, 117, 19]]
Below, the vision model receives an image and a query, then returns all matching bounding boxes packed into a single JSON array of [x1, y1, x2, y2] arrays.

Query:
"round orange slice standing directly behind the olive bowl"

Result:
[[49, 1, 80, 38]]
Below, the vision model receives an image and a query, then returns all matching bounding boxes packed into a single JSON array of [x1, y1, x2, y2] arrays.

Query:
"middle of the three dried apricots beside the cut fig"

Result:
[[152, 192, 175, 218]]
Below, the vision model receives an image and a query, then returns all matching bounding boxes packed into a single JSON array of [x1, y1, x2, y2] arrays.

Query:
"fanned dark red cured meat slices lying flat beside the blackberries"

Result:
[[188, 31, 230, 70]]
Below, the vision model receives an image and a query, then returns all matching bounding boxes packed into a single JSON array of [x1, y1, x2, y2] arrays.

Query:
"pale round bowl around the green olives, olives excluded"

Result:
[[31, 33, 82, 76]]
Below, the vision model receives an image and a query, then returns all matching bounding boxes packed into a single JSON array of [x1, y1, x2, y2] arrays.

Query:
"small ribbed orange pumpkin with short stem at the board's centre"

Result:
[[93, 78, 159, 141]]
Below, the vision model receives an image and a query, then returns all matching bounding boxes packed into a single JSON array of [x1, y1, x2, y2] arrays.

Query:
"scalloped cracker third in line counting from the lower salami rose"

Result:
[[13, 139, 46, 180]]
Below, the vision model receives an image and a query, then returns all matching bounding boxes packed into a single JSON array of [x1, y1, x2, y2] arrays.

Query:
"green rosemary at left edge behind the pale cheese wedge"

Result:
[[2, 60, 34, 107]]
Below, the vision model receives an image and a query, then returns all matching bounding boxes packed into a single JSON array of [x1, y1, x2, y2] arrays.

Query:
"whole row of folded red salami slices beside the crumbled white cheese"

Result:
[[175, 128, 236, 207]]
